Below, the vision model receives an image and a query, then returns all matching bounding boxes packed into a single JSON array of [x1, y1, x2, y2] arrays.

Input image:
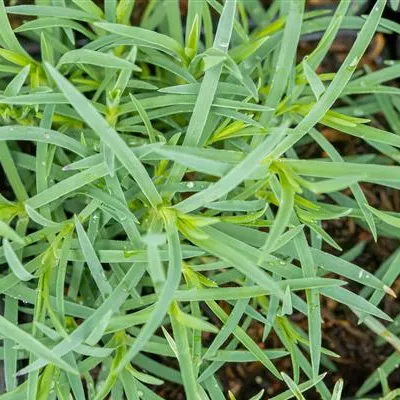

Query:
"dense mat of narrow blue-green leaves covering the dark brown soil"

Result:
[[0, 0, 400, 400]]
